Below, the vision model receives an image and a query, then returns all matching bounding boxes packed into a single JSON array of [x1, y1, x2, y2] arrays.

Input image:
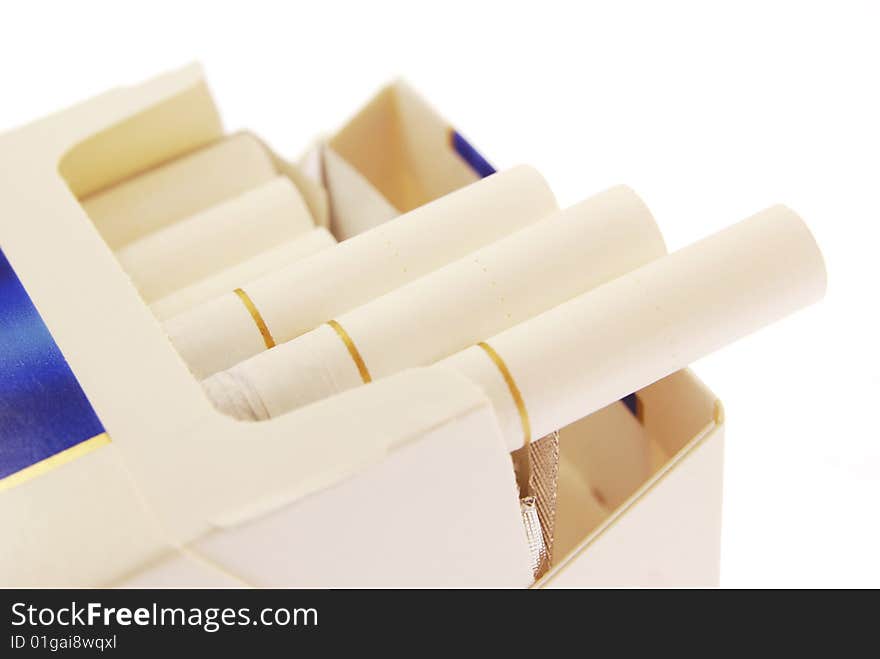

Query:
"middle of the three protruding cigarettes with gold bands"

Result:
[[204, 187, 666, 420]]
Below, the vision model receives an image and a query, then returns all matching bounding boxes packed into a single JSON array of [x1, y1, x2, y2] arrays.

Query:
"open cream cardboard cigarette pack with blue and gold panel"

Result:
[[0, 66, 724, 587]]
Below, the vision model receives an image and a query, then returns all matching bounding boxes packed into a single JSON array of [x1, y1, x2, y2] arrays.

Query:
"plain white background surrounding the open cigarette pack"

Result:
[[0, 0, 880, 586]]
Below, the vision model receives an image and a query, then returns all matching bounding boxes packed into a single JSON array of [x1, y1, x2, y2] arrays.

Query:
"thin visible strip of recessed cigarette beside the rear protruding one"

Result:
[[150, 227, 336, 320]]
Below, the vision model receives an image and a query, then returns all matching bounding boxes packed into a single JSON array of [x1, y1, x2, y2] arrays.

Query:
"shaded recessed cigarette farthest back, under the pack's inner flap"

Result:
[[82, 135, 276, 249]]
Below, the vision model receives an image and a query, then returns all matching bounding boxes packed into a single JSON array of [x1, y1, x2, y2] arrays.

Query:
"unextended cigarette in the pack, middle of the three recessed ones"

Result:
[[116, 176, 315, 302]]
